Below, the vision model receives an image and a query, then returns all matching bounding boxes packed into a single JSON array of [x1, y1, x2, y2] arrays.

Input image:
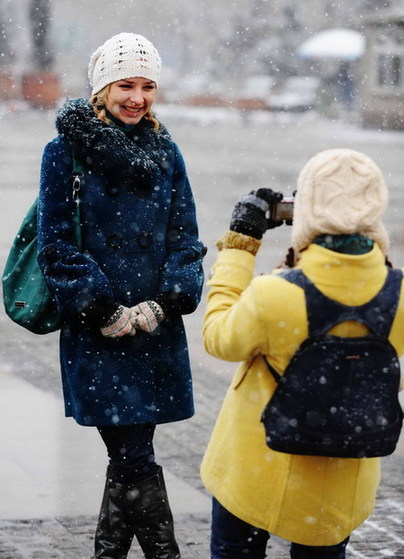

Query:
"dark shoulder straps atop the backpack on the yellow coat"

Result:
[[281, 269, 403, 339]]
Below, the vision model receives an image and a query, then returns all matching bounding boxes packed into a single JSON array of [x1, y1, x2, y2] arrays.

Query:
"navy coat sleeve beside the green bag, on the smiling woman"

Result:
[[38, 137, 116, 322]]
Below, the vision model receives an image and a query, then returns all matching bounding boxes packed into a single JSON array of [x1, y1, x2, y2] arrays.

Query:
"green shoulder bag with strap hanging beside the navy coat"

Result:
[[2, 151, 83, 334]]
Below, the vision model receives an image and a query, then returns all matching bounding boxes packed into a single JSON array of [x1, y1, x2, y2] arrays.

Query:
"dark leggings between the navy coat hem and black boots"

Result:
[[97, 423, 158, 484]]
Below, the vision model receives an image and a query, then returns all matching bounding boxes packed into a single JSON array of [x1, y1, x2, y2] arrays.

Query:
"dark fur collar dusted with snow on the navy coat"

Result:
[[56, 99, 171, 186]]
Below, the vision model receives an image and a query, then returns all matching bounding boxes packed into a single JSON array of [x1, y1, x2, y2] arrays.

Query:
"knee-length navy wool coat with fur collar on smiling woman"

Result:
[[38, 100, 204, 425]]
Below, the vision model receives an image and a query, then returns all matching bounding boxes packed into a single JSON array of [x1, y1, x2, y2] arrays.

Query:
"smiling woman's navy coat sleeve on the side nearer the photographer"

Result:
[[157, 146, 206, 314]]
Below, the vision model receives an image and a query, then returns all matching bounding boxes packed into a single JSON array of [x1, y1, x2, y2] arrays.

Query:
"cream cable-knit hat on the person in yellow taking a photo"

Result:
[[292, 149, 389, 254]]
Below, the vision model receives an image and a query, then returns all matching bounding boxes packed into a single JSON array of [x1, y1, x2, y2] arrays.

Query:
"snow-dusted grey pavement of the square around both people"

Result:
[[0, 107, 404, 559]]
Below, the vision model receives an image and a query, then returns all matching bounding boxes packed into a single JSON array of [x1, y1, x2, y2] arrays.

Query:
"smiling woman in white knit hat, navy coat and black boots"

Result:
[[38, 33, 205, 559]]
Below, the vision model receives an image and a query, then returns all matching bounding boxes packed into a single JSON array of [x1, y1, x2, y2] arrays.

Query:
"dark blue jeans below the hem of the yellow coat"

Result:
[[210, 498, 349, 559]]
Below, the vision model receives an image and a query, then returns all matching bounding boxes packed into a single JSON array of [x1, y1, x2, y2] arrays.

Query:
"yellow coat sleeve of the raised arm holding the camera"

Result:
[[203, 249, 268, 361]]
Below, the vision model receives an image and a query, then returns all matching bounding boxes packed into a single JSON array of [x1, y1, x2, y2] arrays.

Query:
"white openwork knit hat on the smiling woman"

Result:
[[88, 33, 161, 95]]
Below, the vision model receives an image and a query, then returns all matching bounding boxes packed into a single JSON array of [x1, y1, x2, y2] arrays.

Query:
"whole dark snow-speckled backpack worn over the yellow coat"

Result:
[[261, 269, 403, 458]]
